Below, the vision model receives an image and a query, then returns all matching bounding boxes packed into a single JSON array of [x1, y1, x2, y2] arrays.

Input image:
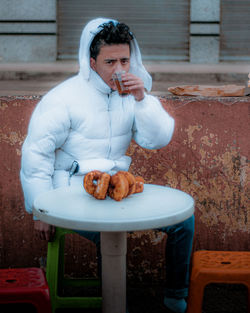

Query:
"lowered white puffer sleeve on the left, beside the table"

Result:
[[20, 99, 70, 213]]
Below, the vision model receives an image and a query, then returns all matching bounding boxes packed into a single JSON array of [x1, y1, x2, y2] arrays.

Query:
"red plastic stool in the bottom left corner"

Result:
[[0, 268, 51, 313]]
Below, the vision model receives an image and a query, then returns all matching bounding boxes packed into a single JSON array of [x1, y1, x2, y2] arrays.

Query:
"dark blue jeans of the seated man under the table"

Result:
[[75, 216, 194, 298]]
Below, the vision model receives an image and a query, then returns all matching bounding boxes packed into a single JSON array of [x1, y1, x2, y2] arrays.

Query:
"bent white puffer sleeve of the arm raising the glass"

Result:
[[133, 95, 174, 149]]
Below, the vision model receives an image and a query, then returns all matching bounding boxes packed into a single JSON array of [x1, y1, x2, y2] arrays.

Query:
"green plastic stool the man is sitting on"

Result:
[[46, 227, 102, 313]]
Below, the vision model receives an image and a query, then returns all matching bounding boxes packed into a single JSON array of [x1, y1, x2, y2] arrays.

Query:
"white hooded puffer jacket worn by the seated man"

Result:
[[20, 19, 174, 213]]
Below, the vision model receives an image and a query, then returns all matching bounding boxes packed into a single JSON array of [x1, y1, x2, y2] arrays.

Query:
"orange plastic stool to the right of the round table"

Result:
[[187, 251, 250, 313]]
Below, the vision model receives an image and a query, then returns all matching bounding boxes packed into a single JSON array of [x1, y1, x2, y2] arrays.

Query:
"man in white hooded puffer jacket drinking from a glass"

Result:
[[20, 18, 194, 312]]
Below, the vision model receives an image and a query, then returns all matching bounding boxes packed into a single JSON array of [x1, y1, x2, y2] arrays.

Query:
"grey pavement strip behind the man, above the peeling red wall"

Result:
[[0, 61, 250, 96]]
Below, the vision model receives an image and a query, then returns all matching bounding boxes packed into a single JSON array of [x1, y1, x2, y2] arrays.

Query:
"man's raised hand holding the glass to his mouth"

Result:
[[122, 73, 145, 101]]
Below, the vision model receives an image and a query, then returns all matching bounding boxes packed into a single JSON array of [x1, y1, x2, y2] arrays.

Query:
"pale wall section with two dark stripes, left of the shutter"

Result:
[[0, 0, 57, 62]]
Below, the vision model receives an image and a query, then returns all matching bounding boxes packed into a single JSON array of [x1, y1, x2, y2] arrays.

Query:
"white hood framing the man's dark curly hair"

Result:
[[79, 18, 152, 91]]
